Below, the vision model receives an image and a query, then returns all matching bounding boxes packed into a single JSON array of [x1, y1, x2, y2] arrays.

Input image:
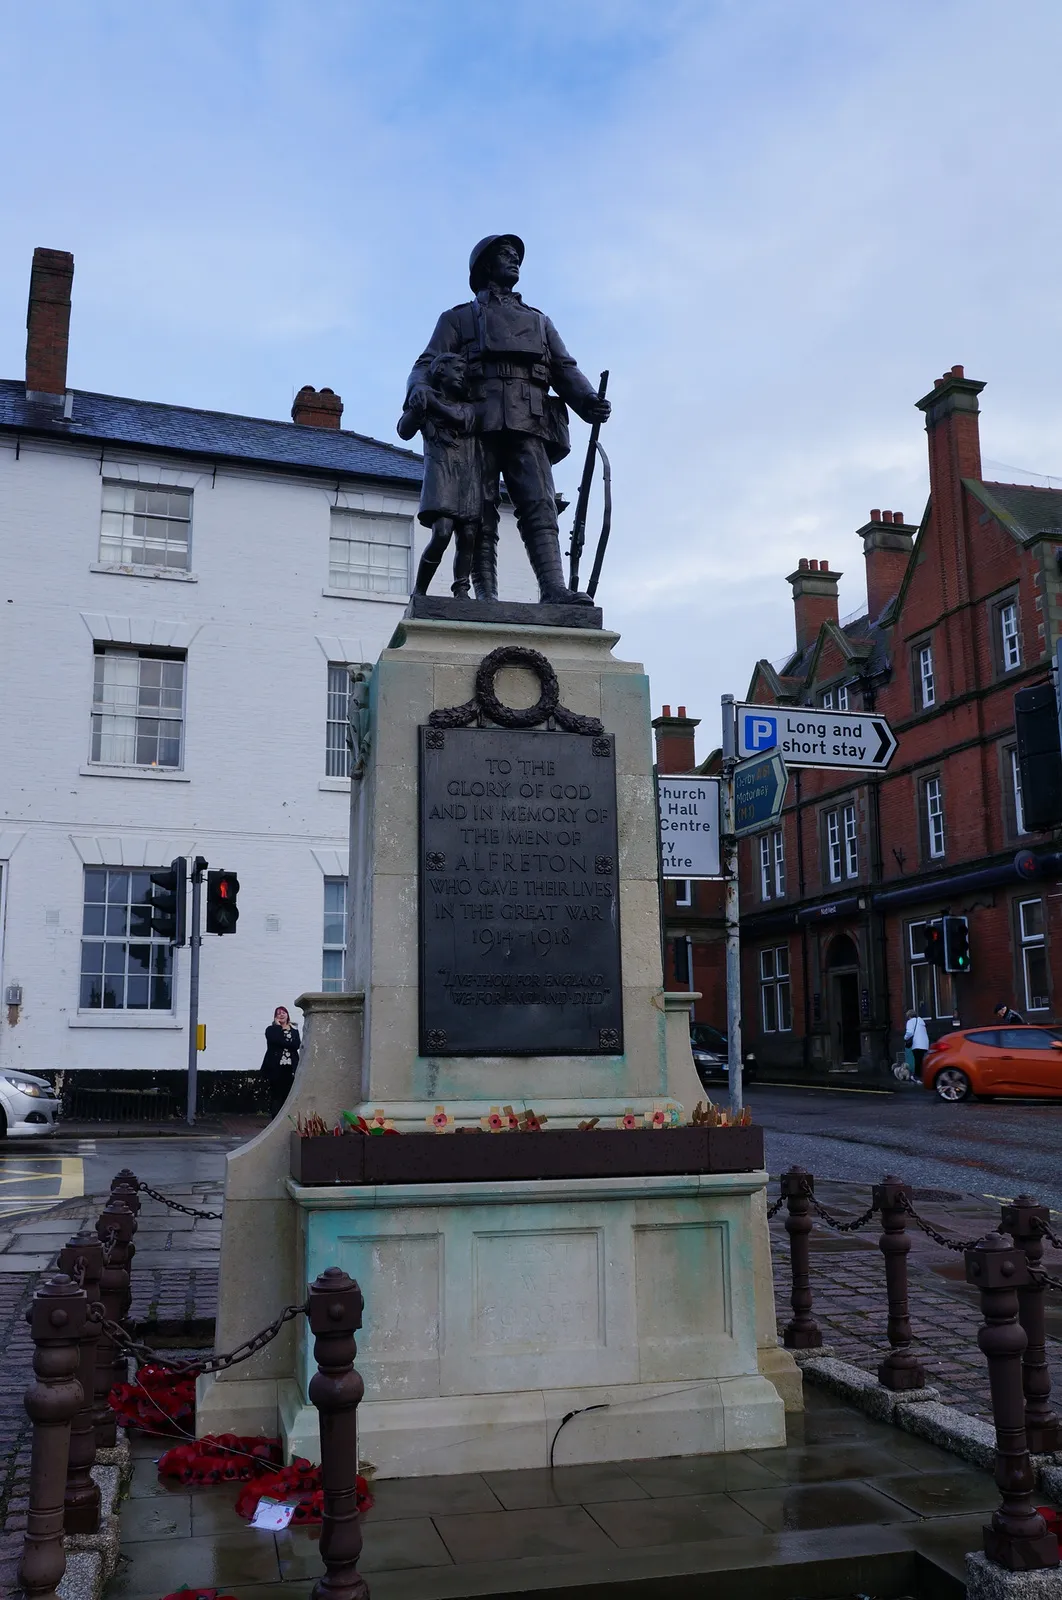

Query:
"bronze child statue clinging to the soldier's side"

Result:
[[398, 352, 483, 597]]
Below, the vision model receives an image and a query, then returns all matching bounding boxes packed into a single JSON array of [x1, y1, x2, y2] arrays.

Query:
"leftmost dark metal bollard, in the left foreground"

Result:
[[19, 1275, 88, 1600]]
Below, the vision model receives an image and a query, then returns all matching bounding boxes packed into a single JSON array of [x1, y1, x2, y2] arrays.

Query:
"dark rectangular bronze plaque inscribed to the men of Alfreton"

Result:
[[421, 728, 624, 1049]]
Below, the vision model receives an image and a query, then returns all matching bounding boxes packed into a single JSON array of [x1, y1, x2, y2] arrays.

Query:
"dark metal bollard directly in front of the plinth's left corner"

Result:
[[309, 1267, 369, 1600]]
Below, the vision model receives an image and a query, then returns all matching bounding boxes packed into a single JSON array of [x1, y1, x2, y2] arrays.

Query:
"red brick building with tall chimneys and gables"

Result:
[[735, 366, 1062, 1069]]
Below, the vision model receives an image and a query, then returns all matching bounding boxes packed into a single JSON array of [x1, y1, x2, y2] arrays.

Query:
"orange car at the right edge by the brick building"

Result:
[[921, 1027, 1062, 1101]]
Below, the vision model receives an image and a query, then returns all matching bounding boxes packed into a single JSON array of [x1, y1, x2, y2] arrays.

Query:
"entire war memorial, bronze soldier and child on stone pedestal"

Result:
[[197, 235, 800, 1477]]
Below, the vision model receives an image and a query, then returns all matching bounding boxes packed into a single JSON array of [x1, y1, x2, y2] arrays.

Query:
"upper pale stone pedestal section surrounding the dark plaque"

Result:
[[347, 618, 704, 1130]]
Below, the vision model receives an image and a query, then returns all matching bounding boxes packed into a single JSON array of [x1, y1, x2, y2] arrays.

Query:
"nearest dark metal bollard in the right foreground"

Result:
[[964, 1234, 1059, 1573]]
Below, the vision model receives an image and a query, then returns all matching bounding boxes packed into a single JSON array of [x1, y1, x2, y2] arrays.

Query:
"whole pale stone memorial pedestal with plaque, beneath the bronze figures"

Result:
[[197, 600, 800, 1477]]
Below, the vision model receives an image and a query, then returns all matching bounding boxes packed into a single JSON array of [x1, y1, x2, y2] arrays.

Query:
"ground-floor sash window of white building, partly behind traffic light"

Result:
[[77, 862, 178, 1016]]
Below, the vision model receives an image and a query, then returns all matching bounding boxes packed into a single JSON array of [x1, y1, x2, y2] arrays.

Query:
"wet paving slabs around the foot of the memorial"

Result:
[[107, 1392, 998, 1600]]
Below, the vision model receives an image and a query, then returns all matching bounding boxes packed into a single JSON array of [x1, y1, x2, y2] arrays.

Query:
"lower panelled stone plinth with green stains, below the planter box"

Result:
[[281, 1164, 785, 1477]]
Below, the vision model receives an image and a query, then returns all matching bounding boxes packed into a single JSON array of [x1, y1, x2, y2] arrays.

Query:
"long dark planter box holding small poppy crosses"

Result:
[[291, 1128, 763, 1187]]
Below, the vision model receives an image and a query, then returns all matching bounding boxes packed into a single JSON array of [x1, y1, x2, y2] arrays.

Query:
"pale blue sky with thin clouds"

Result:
[[0, 0, 1062, 755]]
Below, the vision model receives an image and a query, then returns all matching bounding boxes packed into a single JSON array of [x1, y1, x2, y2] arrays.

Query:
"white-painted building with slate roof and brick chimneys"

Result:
[[0, 251, 533, 1113]]
